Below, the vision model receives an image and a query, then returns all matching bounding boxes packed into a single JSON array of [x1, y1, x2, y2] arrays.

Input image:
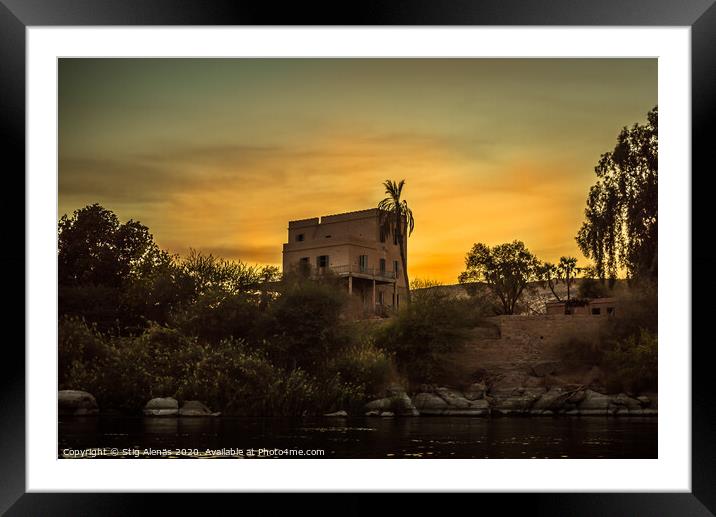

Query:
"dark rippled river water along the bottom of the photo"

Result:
[[58, 416, 657, 458]]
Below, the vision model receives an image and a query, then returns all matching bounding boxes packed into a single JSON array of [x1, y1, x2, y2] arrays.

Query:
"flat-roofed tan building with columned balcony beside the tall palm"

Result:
[[283, 208, 408, 311]]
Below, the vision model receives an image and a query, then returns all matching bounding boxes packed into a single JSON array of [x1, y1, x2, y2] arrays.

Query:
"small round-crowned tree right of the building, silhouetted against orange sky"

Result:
[[458, 241, 540, 314]]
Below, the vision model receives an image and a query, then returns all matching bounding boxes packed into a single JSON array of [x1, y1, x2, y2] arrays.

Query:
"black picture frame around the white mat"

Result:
[[0, 0, 716, 515]]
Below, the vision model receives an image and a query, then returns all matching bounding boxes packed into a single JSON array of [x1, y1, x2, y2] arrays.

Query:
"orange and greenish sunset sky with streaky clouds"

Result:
[[58, 59, 657, 283]]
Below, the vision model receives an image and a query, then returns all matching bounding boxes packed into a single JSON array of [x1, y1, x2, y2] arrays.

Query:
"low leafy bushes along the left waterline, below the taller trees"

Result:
[[59, 318, 380, 415]]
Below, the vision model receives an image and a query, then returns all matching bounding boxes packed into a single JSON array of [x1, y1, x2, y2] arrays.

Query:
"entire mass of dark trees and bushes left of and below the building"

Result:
[[58, 205, 480, 415]]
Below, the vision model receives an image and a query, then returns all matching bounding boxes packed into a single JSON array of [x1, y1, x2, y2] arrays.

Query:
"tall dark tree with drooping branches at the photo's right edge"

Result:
[[576, 107, 658, 280]]
